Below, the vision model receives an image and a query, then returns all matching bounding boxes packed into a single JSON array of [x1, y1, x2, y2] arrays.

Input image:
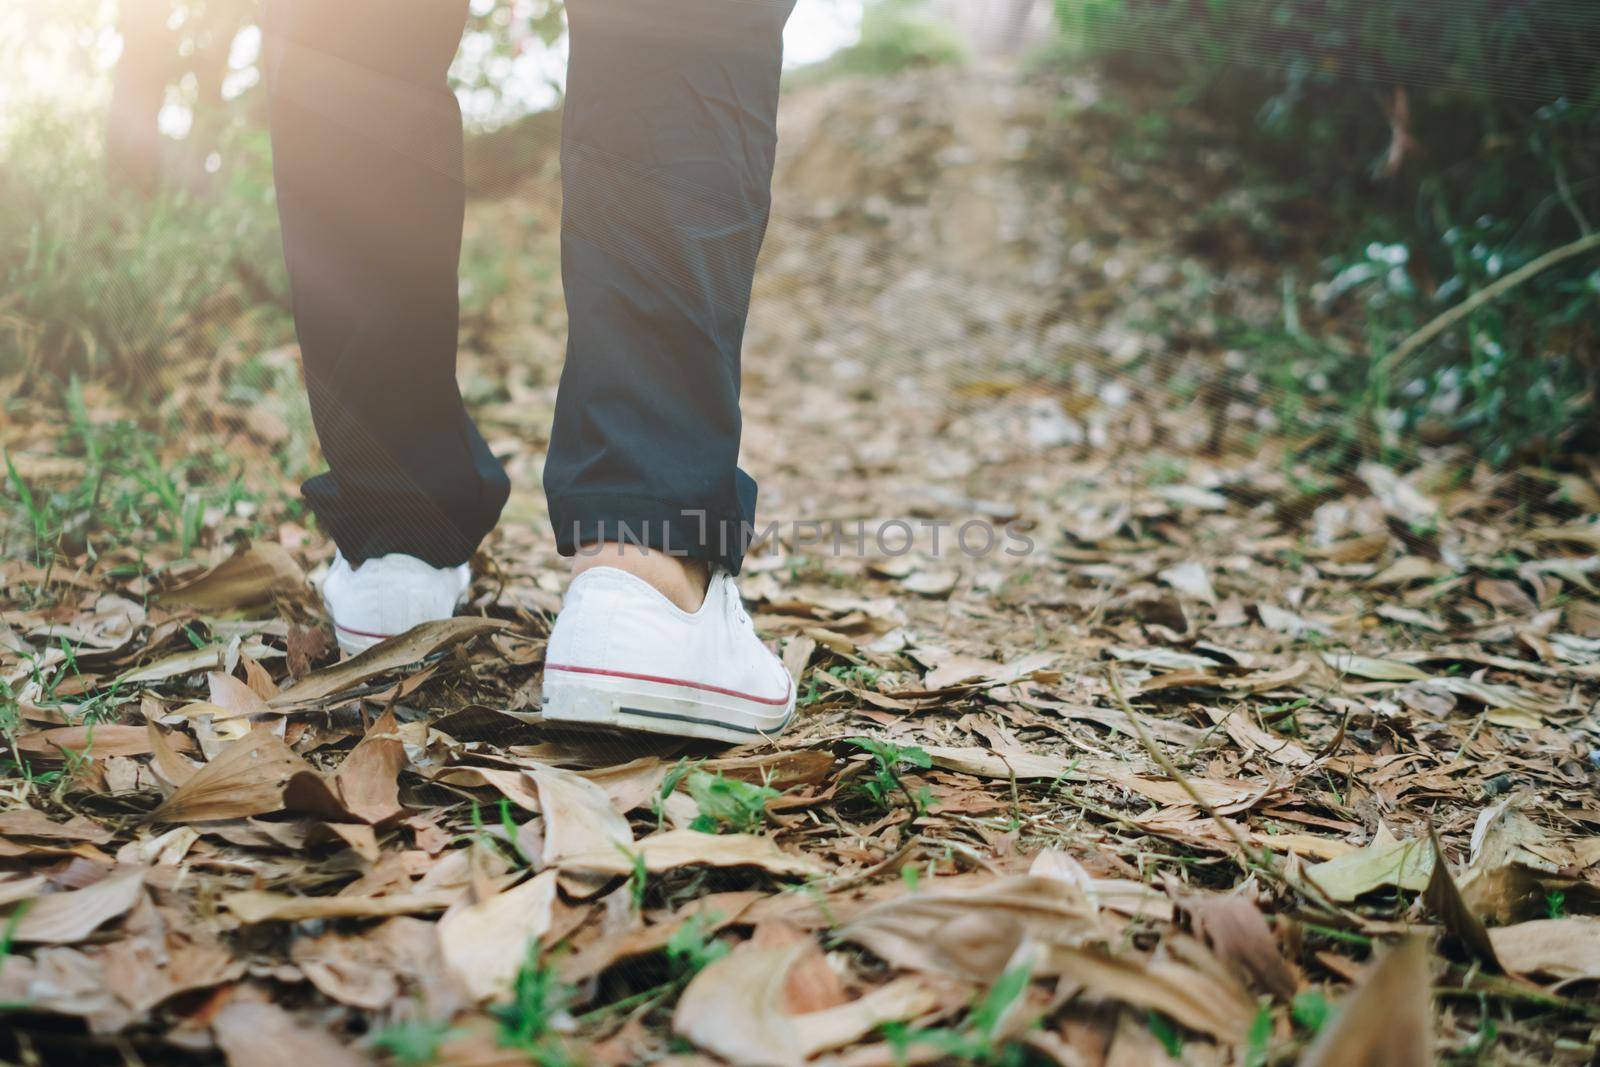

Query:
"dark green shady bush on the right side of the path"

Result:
[[1056, 0, 1600, 461]]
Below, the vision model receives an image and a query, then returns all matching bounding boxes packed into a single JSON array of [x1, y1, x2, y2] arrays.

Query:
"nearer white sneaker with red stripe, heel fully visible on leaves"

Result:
[[544, 566, 795, 744]]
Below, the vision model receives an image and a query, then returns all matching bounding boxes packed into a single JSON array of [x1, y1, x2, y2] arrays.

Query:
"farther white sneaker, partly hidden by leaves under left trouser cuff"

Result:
[[322, 552, 472, 656]]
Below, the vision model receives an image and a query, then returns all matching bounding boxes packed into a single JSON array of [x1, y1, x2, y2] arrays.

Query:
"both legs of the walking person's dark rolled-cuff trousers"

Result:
[[266, 0, 795, 571]]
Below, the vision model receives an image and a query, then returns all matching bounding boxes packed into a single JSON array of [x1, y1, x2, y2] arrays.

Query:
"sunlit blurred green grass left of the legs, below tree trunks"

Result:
[[0, 110, 288, 379]]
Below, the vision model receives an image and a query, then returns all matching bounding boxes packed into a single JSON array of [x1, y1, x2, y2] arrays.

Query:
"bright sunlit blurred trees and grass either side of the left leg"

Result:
[[0, 0, 563, 390]]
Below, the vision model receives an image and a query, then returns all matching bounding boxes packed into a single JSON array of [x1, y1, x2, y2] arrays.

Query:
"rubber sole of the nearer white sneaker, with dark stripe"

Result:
[[544, 667, 795, 744]]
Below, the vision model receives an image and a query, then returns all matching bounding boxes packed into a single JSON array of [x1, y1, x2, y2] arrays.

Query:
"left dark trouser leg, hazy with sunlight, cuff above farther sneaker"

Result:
[[266, 0, 509, 568]]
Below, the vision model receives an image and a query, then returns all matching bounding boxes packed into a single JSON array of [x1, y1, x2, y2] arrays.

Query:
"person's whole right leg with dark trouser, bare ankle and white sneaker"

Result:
[[544, 0, 795, 742]]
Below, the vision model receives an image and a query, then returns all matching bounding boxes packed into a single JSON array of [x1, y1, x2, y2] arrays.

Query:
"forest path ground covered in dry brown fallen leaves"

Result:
[[0, 62, 1600, 1067]]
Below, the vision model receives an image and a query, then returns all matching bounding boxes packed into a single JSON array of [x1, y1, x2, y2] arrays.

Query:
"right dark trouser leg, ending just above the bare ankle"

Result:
[[544, 0, 794, 584]]
